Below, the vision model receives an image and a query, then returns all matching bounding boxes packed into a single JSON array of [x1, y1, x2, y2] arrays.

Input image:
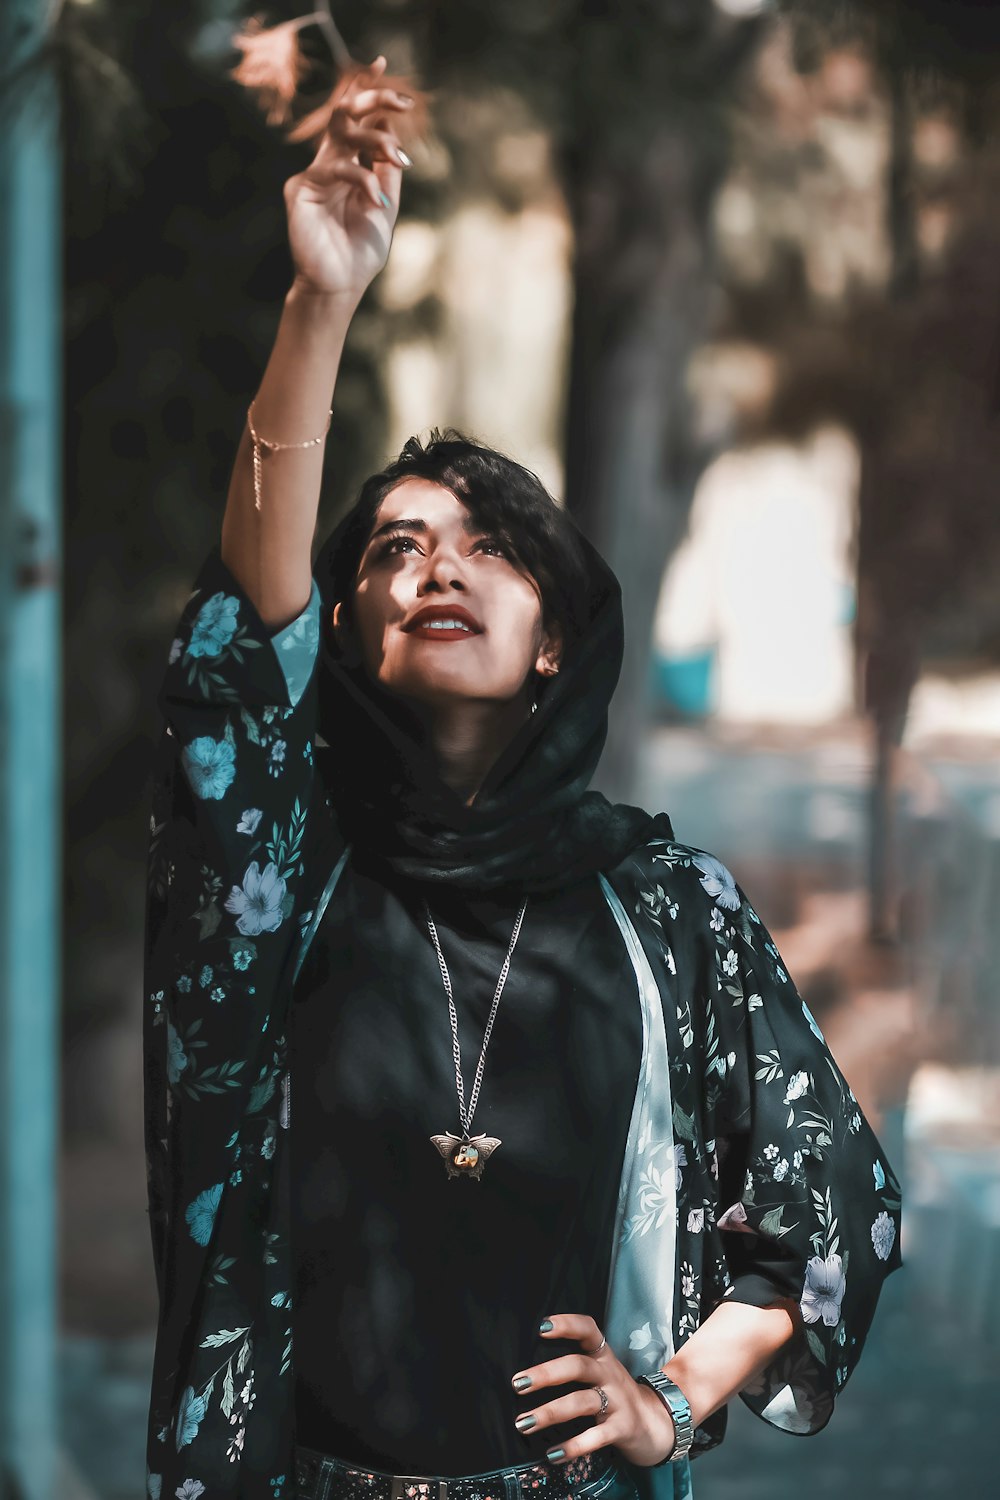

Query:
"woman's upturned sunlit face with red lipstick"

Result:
[[333, 479, 559, 708]]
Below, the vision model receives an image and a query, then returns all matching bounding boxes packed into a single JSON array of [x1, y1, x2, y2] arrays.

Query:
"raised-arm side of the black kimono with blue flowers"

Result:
[[142, 549, 319, 1500]]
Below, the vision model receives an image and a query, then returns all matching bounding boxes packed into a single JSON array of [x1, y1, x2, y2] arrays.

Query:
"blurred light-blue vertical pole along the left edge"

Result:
[[0, 0, 61, 1500]]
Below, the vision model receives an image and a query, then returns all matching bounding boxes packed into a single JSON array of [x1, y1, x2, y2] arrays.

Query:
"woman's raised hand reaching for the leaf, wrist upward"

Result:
[[285, 57, 412, 299]]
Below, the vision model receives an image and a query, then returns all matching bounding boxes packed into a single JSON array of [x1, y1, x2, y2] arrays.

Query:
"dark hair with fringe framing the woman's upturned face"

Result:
[[316, 428, 589, 647]]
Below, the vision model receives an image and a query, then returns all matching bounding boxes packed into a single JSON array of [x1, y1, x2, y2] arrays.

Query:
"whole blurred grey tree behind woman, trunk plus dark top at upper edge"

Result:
[[418, 0, 763, 797]]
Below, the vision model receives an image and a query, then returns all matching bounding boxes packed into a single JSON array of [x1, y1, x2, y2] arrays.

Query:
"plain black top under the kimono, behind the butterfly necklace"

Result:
[[291, 855, 642, 1475]]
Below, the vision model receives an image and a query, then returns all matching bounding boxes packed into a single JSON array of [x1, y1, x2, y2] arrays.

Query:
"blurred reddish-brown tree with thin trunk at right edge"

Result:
[[781, 0, 1000, 939]]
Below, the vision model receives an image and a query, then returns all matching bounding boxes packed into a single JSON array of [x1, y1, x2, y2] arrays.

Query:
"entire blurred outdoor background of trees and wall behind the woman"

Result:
[[0, 0, 1000, 1500]]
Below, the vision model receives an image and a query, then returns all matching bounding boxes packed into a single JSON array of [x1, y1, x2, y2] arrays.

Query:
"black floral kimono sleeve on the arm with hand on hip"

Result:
[[693, 851, 901, 1434]]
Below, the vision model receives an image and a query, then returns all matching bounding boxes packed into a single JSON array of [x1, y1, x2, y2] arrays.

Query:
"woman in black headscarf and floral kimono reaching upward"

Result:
[[144, 59, 900, 1500]]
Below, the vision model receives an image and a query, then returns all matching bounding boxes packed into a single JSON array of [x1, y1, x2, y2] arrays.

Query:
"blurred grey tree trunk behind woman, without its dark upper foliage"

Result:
[[565, 130, 715, 798]]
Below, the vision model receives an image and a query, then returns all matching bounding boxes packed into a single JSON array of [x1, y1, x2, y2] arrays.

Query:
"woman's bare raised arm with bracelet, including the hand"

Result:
[[222, 57, 411, 630]]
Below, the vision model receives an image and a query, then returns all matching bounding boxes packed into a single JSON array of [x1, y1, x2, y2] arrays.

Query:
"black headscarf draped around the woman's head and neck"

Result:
[[313, 524, 672, 893]]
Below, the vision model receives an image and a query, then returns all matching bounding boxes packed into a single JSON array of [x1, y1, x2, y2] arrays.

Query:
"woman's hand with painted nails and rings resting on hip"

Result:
[[511, 1313, 675, 1467]]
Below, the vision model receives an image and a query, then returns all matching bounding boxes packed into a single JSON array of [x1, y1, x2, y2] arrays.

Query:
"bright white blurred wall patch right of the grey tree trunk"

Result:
[[654, 426, 859, 725]]
